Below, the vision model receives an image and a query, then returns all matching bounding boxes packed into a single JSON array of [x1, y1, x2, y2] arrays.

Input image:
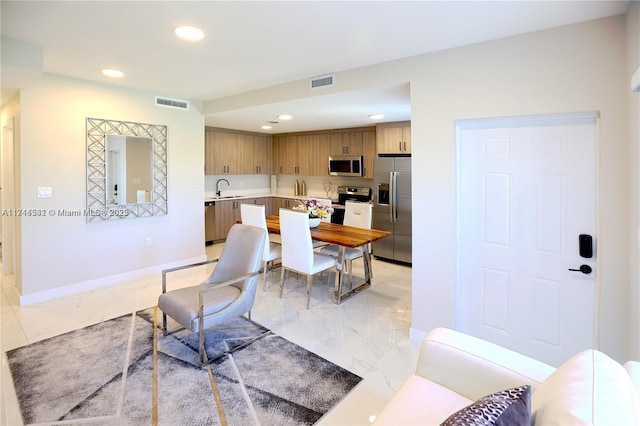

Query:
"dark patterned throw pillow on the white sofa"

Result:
[[441, 385, 531, 426]]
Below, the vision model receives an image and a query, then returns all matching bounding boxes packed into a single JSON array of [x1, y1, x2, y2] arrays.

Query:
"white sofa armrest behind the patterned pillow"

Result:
[[416, 328, 555, 401]]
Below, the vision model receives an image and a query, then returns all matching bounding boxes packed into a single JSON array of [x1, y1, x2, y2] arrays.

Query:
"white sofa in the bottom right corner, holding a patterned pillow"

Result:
[[374, 328, 640, 426]]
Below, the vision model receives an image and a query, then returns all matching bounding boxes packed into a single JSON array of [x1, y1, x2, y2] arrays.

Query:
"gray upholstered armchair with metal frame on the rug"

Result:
[[158, 224, 266, 364]]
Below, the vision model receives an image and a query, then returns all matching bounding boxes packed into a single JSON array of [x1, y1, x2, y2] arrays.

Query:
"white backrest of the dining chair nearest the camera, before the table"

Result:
[[280, 209, 313, 273]]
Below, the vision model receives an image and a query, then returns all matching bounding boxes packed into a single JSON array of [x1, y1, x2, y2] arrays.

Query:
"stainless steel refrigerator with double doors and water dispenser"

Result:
[[372, 156, 411, 263]]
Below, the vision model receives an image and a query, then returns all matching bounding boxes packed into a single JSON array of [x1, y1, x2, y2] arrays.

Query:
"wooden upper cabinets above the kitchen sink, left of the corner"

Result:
[[204, 127, 271, 175]]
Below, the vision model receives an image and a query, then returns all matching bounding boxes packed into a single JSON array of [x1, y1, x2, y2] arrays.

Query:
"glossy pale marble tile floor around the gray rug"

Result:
[[0, 244, 419, 426]]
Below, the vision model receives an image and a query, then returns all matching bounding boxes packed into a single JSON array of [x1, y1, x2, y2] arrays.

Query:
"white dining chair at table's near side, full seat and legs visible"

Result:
[[280, 209, 336, 309]]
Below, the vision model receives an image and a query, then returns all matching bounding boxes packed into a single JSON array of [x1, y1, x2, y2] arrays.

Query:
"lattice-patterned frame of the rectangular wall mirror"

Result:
[[85, 117, 168, 223]]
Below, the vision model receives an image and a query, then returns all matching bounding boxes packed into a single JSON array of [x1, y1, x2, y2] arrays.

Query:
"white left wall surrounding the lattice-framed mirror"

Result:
[[15, 75, 204, 302]]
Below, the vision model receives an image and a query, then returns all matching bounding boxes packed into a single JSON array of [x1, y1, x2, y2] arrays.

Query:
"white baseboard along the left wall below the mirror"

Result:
[[20, 255, 207, 306]]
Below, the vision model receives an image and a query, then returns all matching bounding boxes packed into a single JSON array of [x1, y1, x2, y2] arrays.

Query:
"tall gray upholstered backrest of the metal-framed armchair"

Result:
[[204, 224, 267, 291]]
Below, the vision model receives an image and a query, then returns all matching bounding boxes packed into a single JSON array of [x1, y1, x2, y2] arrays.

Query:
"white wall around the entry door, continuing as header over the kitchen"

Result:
[[205, 15, 639, 360]]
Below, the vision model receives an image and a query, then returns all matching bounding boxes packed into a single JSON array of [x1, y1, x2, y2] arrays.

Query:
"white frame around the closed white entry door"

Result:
[[454, 111, 602, 356]]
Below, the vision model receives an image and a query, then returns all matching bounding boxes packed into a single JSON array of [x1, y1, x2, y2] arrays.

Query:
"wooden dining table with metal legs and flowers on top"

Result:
[[267, 215, 391, 304]]
